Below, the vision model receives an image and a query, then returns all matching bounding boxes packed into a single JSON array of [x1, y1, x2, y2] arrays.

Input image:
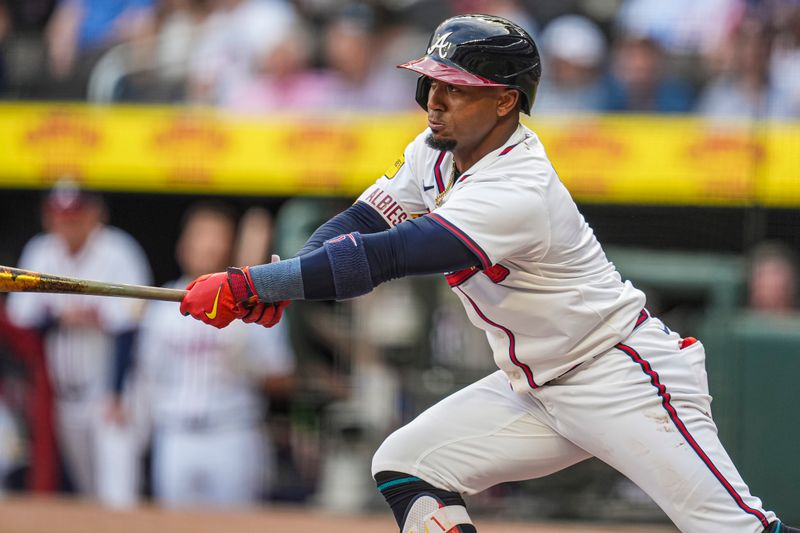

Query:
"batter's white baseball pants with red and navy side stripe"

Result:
[[372, 318, 775, 533]]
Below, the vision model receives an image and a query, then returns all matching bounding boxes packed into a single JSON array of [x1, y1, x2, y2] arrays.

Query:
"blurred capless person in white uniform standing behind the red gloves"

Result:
[[136, 204, 293, 507]]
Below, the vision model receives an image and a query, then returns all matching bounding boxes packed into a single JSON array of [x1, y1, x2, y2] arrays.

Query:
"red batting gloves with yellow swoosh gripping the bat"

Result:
[[180, 267, 289, 328]]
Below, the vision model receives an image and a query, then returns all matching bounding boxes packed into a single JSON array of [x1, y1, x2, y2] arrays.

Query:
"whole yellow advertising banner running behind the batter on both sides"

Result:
[[0, 104, 800, 207]]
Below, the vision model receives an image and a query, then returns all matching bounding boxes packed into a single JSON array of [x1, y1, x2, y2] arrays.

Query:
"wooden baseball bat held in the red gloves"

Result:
[[0, 266, 186, 302]]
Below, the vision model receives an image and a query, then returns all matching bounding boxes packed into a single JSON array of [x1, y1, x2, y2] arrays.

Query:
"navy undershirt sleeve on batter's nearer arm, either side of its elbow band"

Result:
[[300, 215, 480, 300]]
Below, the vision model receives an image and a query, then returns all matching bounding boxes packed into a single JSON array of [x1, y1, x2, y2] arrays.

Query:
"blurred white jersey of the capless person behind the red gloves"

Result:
[[137, 279, 294, 427]]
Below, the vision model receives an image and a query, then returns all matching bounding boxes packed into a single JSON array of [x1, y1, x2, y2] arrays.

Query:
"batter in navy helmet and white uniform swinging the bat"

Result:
[[181, 15, 798, 533]]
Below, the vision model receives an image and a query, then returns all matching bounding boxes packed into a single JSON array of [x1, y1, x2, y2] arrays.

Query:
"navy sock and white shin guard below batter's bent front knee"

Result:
[[375, 471, 476, 533]]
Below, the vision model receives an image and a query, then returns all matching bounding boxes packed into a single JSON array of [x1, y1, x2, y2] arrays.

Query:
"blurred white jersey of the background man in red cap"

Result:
[[8, 226, 151, 402]]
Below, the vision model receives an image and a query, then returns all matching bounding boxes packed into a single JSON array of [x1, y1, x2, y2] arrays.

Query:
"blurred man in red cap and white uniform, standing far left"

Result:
[[8, 182, 151, 503]]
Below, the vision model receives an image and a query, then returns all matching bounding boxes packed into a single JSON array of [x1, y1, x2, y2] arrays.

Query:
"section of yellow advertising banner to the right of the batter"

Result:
[[533, 116, 800, 207]]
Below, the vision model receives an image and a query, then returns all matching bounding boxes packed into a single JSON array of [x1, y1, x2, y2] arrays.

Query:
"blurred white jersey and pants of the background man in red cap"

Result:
[[8, 226, 150, 498]]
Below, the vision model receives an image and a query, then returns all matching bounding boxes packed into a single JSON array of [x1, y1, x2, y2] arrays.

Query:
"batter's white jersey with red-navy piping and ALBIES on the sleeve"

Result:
[[359, 125, 645, 392]]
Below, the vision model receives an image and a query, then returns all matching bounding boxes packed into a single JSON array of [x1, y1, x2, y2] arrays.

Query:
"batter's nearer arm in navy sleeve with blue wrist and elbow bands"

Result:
[[250, 215, 479, 302]]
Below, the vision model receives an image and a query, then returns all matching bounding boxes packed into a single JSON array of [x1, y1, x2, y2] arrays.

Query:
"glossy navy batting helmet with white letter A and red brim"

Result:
[[400, 15, 542, 114]]
